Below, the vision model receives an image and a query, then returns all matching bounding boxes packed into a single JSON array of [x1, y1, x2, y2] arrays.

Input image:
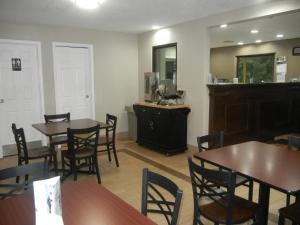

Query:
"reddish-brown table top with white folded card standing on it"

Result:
[[0, 180, 155, 225]]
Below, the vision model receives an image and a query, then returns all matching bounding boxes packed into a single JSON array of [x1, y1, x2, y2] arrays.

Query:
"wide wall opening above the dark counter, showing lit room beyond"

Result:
[[209, 11, 300, 83]]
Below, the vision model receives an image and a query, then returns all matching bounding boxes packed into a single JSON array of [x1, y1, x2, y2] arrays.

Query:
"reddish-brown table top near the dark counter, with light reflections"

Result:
[[194, 141, 300, 192]]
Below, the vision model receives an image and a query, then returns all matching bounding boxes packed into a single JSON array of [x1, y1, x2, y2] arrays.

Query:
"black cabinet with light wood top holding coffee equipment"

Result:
[[133, 103, 190, 154]]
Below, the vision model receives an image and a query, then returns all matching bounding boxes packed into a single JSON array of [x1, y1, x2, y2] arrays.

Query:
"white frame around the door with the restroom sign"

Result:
[[0, 39, 45, 158]]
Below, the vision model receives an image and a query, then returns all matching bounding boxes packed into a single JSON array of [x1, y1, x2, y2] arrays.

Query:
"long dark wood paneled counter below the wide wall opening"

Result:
[[207, 83, 300, 144]]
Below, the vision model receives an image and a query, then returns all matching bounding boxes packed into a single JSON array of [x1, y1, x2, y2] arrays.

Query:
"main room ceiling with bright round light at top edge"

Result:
[[0, 0, 275, 33]]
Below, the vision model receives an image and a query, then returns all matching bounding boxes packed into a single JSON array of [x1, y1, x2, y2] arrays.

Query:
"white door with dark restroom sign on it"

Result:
[[0, 40, 43, 157]]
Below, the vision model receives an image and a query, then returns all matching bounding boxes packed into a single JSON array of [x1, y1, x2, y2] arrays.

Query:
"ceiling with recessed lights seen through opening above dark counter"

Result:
[[210, 12, 300, 48]]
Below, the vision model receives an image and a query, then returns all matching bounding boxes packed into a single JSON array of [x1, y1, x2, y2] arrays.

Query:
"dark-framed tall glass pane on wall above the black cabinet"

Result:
[[152, 43, 177, 95]]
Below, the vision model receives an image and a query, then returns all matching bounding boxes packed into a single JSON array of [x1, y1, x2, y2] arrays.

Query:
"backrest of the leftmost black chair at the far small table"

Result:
[[11, 123, 28, 163]]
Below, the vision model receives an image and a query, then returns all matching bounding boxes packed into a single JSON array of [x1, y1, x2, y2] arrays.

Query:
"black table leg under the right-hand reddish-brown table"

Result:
[[257, 183, 270, 225]]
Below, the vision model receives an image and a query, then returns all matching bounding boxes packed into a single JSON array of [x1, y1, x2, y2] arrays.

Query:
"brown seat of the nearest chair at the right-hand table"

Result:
[[199, 196, 258, 224]]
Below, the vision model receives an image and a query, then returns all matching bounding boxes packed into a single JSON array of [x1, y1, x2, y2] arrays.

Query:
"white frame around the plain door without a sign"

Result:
[[52, 42, 96, 119]]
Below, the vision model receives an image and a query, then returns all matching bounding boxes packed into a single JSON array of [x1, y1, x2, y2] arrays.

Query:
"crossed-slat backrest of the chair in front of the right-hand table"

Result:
[[188, 157, 236, 224]]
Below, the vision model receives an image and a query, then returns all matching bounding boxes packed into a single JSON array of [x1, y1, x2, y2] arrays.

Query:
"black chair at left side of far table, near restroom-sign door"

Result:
[[11, 123, 57, 178]]
